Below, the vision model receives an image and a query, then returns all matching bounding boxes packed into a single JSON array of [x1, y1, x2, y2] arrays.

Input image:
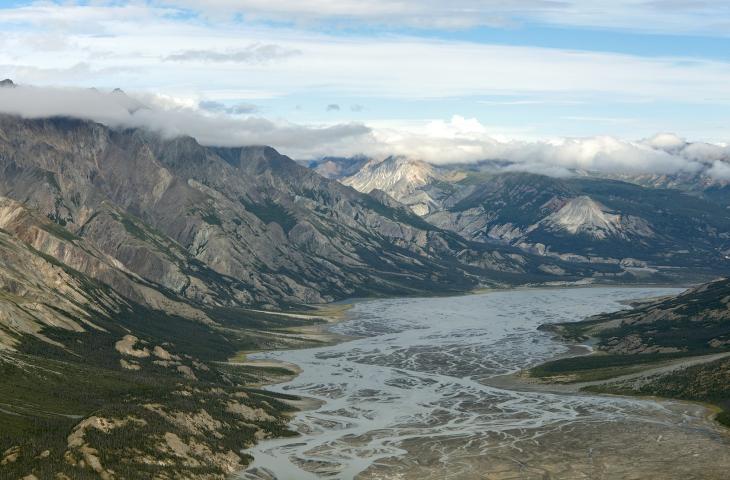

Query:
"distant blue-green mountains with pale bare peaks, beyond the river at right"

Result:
[[342, 158, 730, 278]]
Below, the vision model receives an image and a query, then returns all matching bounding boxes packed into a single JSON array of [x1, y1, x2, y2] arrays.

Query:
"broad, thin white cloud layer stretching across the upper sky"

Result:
[[0, 0, 730, 105]]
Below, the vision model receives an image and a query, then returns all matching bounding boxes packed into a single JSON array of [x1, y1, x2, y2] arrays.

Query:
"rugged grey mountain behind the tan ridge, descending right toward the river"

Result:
[[0, 116, 588, 312]]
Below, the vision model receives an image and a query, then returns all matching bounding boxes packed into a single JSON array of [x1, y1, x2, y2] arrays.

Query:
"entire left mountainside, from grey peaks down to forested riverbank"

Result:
[[0, 115, 626, 479]]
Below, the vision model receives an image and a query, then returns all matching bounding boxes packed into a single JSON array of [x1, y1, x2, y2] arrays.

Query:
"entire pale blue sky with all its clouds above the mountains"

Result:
[[0, 0, 730, 171]]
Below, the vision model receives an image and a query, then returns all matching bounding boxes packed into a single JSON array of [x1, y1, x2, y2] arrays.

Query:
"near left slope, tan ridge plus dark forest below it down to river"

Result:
[[0, 199, 324, 480]]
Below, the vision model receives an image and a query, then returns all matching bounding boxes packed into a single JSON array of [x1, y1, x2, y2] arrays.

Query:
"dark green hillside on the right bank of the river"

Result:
[[530, 279, 730, 432]]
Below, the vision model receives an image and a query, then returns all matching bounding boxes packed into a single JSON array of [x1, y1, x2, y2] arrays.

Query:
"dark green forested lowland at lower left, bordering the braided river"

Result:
[[0, 298, 326, 480]]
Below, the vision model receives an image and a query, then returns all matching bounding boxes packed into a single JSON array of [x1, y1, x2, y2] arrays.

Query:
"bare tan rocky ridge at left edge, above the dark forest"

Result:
[[0, 197, 213, 346]]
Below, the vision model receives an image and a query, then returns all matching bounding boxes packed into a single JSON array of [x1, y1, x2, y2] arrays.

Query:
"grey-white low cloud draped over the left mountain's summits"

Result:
[[0, 86, 370, 155]]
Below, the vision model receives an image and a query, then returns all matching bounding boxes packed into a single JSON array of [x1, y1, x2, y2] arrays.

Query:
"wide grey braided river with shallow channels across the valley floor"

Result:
[[241, 288, 730, 480]]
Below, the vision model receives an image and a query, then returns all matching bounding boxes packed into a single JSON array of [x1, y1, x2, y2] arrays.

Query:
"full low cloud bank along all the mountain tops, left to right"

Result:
[[0, 86, 730, 181]]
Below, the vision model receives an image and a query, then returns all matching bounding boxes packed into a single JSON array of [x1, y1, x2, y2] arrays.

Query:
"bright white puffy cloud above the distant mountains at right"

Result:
[[329, 116, 730, 177]]
